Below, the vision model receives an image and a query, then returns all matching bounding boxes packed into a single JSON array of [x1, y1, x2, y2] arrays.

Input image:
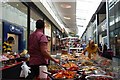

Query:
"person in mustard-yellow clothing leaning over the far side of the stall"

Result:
[[82, 40, 101, 59]]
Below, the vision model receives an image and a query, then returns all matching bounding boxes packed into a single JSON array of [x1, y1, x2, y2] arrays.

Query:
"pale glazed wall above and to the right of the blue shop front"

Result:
[[2, 2, 28, 49]]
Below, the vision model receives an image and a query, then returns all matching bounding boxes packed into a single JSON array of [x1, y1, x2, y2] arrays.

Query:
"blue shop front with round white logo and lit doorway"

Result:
[[3, 22, 25, 53]]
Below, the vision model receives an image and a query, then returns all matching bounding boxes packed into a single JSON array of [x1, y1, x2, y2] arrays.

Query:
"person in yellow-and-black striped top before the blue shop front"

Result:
[[3, 36, 15, 53]]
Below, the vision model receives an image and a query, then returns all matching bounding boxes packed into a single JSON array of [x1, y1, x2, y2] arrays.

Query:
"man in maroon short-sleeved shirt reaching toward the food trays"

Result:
[[29, 20, 59, 78]]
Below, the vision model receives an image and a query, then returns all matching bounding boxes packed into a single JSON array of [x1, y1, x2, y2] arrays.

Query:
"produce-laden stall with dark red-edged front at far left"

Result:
[[0, 50, 28, 80]]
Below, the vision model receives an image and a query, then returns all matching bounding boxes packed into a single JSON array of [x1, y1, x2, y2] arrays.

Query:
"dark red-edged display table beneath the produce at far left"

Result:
[[0, 58, 29, 80]]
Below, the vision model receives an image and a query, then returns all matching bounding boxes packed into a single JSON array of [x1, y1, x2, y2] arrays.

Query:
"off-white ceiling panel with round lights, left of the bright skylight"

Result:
[[53, 2, 78, 33]]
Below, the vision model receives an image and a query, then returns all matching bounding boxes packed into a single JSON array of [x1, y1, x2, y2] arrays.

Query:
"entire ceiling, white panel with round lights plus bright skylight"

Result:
[[48, 0, 101, 36]]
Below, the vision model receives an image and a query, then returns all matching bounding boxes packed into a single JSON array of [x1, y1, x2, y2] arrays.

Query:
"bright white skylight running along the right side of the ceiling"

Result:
[[76, 0, 102, 36]]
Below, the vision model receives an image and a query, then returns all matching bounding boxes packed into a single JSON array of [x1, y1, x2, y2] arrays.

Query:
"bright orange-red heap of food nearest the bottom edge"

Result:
[[53, 70, 75, 79]]
